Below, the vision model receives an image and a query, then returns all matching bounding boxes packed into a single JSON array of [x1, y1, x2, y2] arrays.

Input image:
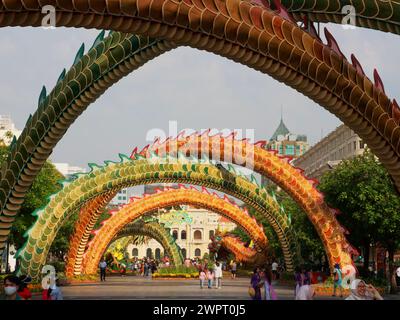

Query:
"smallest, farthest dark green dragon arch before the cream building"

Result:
[[110, 220, 183, 266]]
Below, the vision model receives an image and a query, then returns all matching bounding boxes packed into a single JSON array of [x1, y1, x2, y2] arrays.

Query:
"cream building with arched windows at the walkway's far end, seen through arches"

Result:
[[127, 206, 236, 259]]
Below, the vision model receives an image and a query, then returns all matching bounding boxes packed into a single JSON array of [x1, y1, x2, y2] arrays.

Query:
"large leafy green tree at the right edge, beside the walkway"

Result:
[[319, 151, 400, 292]]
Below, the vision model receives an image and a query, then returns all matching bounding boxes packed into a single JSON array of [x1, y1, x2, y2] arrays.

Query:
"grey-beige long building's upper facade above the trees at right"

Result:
[[293, 124, 366, 179]]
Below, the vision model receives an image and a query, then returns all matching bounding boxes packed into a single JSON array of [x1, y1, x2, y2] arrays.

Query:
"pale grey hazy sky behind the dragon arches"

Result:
[[0, 25, 400, 174]]
